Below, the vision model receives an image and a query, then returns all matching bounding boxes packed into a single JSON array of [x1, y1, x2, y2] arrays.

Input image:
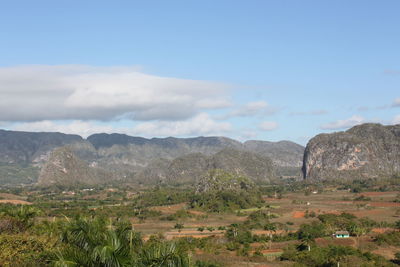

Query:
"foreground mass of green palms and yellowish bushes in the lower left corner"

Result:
[[0, 205, 200, 267]]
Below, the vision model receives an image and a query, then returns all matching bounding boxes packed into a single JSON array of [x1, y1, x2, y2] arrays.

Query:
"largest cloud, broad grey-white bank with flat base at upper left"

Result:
[[0, 65, 230, 121]]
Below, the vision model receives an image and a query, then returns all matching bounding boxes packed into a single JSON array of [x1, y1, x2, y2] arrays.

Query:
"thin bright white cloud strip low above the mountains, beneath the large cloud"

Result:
[[8, 113, 232, 137]]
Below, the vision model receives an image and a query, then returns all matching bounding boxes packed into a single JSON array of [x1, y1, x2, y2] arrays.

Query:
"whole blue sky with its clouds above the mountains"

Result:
[[0, 0, 400, 145]]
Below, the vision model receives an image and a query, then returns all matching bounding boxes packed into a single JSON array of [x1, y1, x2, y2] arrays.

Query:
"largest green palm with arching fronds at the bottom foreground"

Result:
[[56, 218, 141, 267]]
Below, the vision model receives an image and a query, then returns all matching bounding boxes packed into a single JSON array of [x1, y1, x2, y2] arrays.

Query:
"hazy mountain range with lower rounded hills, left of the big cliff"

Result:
[[0, 130, 304, 185]]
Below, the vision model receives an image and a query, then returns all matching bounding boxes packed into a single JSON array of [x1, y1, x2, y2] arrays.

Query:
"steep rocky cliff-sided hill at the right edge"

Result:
[[303, 124, 400, 179]]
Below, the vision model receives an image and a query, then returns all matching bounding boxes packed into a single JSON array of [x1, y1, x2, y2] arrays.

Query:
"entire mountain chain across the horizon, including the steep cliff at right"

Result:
[[0, 123, 400, 186]]
